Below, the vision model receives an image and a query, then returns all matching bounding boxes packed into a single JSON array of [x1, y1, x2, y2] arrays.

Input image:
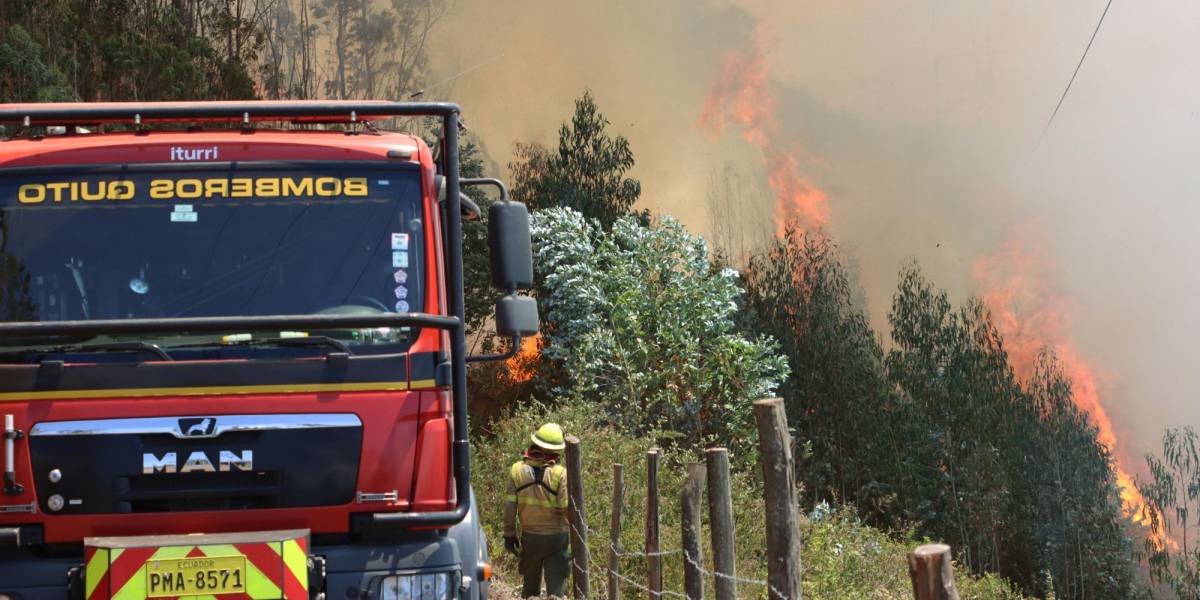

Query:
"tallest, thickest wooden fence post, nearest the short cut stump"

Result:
[[754, 398, 800, 600]]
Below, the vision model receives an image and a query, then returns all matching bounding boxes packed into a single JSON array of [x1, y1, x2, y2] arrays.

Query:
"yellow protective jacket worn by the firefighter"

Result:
[[504, 458, 568, 538]]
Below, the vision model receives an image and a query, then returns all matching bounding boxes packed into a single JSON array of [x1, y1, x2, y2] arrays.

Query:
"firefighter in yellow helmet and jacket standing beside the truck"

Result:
[[504, 422, 570, 598]]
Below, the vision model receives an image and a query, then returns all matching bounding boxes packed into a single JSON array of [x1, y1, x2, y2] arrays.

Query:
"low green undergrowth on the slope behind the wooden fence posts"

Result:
[[473, 401, 1021, 600]]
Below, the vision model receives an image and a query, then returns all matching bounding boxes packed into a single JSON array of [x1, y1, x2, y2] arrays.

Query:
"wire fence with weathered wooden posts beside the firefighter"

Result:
[[549, 398, 959, 600]]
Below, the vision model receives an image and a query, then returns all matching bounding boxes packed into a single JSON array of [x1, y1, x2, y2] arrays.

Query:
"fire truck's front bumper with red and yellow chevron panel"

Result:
[[0, 532, 486, 600]]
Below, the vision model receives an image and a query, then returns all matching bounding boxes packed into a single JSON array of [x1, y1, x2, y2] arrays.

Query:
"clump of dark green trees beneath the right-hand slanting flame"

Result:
[[887, 268, 1133, 598]]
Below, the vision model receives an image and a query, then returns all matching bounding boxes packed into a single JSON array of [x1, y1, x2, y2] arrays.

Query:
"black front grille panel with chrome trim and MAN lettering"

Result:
[[30, 414, 362, 515]]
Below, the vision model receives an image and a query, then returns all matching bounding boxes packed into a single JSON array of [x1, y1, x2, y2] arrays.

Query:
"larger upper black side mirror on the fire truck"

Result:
[[487, 200, 533, 292]]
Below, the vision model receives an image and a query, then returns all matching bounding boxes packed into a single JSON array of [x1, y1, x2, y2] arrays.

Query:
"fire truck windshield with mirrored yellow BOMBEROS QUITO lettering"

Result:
[[0, 163, 426, 346]]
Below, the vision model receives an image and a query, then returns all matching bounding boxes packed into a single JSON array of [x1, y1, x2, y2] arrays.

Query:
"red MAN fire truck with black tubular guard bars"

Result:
[[0, 102, 538, 600]]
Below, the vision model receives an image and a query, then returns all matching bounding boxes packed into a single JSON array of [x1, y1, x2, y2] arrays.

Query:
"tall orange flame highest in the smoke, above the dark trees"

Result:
[[700, 29, 829, 238]]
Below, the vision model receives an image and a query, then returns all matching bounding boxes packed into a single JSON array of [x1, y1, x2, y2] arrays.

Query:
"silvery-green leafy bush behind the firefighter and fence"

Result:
[[533, 209, 787, 448]]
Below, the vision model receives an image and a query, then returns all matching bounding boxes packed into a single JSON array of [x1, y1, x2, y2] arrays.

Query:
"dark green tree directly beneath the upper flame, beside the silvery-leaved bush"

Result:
[[740, 227, 899, 524]]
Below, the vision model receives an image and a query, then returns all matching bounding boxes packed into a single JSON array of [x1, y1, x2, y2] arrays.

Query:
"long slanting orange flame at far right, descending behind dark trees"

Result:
[[971, 227, 1169, 544]]
